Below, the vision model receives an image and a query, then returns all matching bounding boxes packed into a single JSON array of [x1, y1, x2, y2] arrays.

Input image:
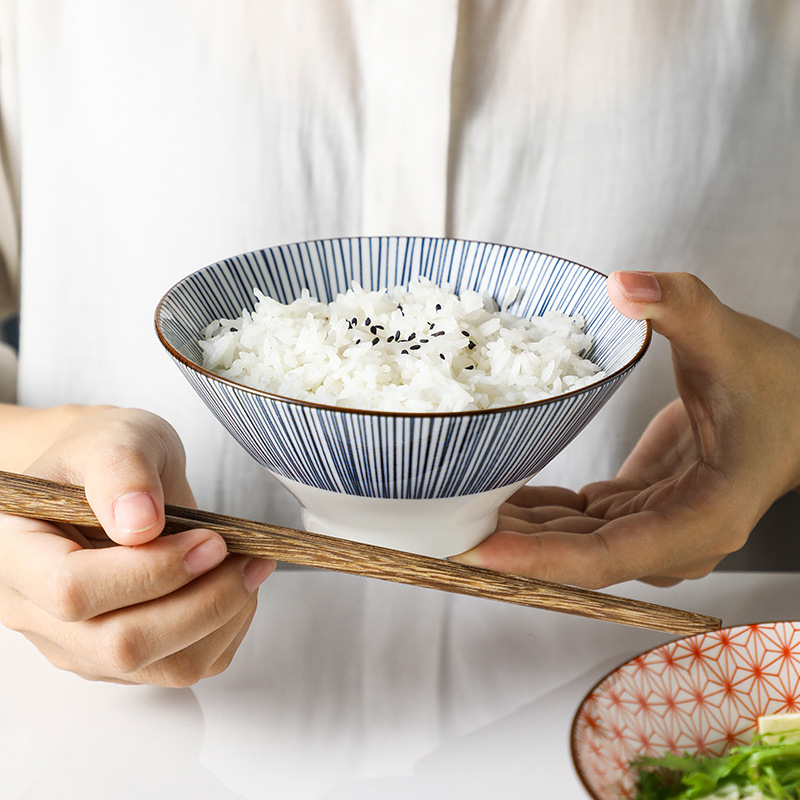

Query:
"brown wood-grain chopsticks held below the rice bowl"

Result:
[[0, 471, 722, 635]]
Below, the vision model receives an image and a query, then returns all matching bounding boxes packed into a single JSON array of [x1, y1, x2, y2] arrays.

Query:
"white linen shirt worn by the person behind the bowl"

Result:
[[0, 0, 800, 525]]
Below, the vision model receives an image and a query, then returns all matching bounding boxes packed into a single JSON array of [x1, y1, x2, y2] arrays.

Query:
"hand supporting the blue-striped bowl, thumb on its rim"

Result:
[[455, 273, 800, 588]]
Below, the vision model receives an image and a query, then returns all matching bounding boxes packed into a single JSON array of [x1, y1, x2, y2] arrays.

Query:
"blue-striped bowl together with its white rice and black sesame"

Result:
[[155, 237, 651, 557]]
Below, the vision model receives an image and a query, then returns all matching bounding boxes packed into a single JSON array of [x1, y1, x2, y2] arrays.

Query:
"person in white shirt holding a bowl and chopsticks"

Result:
[[0, 0, 800, 686]]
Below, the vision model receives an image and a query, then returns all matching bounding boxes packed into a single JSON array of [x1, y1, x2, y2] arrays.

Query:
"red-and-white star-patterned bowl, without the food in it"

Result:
[[571, 622, 800, 800]]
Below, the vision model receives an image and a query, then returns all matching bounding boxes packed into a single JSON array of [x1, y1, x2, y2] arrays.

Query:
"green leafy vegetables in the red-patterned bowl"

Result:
[[631, 731, 800, 800]]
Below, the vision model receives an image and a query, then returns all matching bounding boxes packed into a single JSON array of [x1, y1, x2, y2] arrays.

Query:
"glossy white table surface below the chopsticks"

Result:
[[0, 570, 800, 800]]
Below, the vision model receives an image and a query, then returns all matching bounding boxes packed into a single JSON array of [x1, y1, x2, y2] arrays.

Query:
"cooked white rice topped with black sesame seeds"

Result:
[[200, 280, 604, 412]]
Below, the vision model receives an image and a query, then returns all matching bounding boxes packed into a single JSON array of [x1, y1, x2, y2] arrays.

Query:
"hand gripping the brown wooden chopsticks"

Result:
[[0, 408, 275, 687]]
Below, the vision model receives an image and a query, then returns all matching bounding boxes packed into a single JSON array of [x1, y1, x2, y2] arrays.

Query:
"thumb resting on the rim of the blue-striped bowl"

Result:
[[607, 271, 734, 381]]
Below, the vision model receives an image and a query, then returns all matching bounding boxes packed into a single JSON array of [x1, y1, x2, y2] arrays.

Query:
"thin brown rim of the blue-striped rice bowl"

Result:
[[154, 235, 653, 419]]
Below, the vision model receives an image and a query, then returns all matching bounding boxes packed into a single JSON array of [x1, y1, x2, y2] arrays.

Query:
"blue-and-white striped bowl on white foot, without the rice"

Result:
[[155, 237, 650, 556]]
